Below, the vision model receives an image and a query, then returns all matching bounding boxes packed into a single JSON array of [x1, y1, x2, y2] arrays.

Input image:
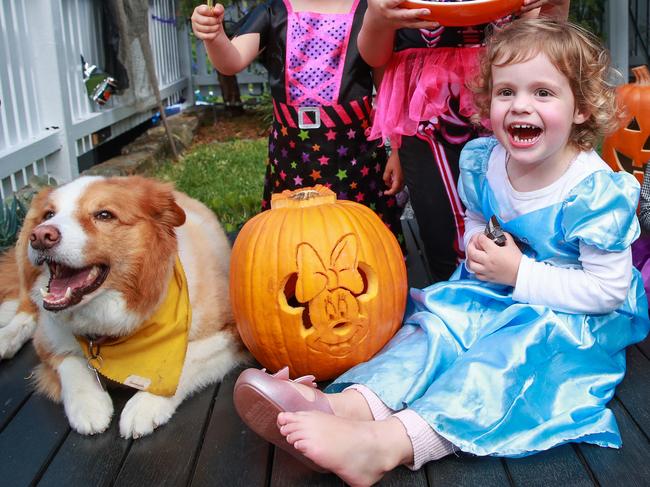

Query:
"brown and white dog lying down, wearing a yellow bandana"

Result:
[[0, 177, 246, 438]]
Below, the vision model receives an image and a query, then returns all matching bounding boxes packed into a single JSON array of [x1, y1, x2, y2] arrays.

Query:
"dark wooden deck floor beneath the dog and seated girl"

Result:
[[0, 221, 650, 487]]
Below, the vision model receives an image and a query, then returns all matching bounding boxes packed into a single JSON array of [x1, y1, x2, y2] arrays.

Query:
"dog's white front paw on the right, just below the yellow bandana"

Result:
[[120, 391, 177, 438]]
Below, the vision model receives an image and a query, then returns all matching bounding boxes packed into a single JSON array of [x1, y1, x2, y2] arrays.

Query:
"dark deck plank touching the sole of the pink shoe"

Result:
[[192, 369, 271, 487]]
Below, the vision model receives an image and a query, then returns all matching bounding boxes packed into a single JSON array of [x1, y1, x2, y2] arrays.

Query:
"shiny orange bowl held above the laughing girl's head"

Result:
[[400, 0, 524, 27]]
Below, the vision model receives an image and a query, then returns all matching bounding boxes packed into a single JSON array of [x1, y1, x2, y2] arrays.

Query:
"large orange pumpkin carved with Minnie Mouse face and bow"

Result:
[[230, 186, 407, 380]]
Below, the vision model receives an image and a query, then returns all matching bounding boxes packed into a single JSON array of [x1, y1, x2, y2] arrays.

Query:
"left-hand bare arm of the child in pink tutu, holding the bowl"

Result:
[[357, 0, 438, 67]]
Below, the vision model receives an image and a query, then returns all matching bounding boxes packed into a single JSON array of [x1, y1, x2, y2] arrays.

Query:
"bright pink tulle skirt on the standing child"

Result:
[[369, 46, 483, 148]]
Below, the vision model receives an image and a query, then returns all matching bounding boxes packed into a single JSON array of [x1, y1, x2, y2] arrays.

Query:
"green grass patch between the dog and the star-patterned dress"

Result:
[[150, 138, 268, 232]]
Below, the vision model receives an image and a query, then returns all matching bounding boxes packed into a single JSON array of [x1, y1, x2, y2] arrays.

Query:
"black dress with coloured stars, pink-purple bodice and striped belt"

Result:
[[237, 0, 403, 244]]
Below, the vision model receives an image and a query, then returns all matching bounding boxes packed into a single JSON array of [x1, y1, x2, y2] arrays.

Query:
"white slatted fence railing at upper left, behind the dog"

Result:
[[0, 0, 192, 198]]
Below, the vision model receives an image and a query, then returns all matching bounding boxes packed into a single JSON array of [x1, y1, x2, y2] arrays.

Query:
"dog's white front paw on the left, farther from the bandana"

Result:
[[63, 391, 113, 435]]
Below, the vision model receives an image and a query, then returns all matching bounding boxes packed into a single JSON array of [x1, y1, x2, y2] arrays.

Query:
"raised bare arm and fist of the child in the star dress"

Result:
[[192, 4, 260, 75]]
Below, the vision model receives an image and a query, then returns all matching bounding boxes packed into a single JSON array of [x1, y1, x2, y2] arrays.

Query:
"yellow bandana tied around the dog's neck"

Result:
[[76, 256, 192, 396]]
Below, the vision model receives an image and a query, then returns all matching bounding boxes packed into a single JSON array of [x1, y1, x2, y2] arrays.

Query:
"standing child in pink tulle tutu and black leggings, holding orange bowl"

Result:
[[358, 0, 569, 282]]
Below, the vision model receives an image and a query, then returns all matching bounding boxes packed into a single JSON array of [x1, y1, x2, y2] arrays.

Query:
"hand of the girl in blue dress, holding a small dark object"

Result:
[[466, 232, 522, 286]]
